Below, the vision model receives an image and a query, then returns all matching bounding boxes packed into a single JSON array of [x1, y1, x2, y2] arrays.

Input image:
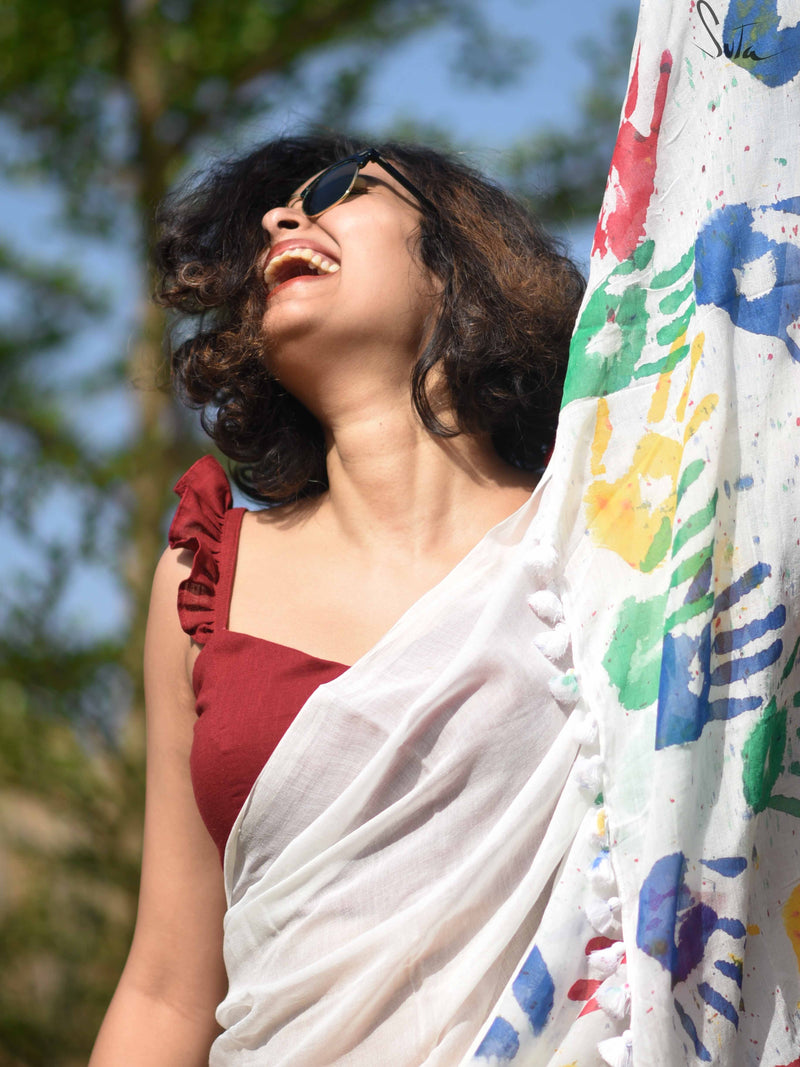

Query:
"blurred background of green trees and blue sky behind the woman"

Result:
[[0, 0, 636, 1067]]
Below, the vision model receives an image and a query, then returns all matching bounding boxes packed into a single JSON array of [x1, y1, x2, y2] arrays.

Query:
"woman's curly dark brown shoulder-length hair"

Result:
[[156, 134, 585, 501]]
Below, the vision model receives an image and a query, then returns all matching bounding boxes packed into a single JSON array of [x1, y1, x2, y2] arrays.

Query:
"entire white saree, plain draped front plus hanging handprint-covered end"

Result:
[[211, 0, 800, 1067]]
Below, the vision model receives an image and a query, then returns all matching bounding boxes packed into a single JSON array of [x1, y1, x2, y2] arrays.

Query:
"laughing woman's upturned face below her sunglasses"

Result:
[[261, 163, 441, 399]]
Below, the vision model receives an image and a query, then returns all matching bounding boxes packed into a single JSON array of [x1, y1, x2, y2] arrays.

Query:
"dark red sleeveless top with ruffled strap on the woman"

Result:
[[170, 456, 348, 859]]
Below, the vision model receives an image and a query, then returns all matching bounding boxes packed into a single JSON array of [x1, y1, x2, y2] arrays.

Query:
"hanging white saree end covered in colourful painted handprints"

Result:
[[475, 0, 800, 1067]]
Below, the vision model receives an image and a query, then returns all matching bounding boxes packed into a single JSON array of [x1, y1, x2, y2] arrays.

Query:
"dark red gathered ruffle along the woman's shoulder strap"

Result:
[[170, 456, 234, 644]]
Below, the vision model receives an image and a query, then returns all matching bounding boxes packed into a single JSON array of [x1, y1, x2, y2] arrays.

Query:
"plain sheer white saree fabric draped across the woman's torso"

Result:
[[210, 486, 587, 1067]]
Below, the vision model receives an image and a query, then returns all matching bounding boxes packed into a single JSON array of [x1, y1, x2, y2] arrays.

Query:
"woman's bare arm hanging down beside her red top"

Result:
[[90, 550, 226, 1067]]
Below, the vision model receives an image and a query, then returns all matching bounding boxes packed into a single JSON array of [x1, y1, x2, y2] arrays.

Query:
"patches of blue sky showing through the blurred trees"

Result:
[[0, 0, 636, 634]]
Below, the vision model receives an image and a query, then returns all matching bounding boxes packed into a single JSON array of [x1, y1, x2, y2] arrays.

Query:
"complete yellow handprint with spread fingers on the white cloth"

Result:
[[583, 333, 719, 572]]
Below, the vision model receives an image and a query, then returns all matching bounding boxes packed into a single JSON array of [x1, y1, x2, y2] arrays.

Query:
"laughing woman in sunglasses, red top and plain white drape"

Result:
[[92, 138, 583, 1067]]
